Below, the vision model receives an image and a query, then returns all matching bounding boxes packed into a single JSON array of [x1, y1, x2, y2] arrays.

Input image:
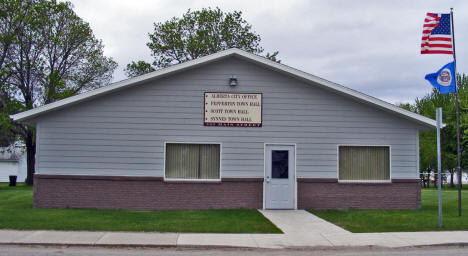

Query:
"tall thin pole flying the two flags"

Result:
[[450, 8, 462, 216]]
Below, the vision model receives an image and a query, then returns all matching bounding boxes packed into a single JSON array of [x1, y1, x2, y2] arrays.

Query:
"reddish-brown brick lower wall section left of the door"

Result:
[[34, 175, 263, 210]]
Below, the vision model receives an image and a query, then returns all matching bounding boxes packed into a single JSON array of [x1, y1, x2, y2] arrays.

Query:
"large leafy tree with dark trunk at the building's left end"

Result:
[[0, 0, 117, 184]]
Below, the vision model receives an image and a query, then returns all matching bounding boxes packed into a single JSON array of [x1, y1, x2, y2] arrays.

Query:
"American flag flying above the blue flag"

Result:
[[421, 13, 453, 54]]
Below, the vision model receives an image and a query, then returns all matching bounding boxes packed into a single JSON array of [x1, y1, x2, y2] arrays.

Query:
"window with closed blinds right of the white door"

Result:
[[338, 146, 390, 181]]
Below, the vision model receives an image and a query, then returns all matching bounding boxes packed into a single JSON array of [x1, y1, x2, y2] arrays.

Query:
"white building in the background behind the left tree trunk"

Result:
[[0, 143, 27, 182]]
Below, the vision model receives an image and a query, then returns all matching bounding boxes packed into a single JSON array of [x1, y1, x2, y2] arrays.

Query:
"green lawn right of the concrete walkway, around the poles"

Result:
[[310, 187, 468, 233]]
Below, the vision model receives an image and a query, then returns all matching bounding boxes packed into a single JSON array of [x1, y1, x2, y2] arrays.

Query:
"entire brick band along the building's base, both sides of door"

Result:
[[34, 175, 421, 210]]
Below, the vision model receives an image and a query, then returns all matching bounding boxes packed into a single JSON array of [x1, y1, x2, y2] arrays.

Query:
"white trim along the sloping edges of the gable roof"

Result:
[[11, 48, 436, 128]]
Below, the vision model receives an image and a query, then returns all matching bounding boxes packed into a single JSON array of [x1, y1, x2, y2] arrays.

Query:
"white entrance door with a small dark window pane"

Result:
[[265, 145, 296, 209]]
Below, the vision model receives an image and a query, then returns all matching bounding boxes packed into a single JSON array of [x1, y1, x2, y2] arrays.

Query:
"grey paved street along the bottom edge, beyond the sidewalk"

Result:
[[0, 246, 468, 256]]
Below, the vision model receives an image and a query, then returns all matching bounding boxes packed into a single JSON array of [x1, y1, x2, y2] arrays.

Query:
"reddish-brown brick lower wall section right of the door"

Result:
[[297, 179, 421, 210]]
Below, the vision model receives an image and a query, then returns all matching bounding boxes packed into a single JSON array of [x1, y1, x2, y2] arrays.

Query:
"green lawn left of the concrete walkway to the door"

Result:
[[0, 183, 281, 233]]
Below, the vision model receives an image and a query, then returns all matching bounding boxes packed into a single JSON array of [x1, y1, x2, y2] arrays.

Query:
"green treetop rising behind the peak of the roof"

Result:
[[125, 8, 280, 77]]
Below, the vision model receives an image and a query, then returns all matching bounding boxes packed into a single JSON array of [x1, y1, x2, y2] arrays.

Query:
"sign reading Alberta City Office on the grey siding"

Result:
[[204, 92, 262, 127]]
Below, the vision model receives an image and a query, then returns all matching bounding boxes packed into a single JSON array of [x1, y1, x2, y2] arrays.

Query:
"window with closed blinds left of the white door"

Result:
[[165, 143, 220, 179]]
